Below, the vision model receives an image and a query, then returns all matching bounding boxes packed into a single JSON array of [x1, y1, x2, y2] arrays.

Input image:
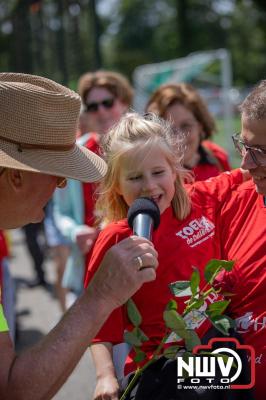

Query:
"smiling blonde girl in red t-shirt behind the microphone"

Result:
[[85, 113, 243, 400]]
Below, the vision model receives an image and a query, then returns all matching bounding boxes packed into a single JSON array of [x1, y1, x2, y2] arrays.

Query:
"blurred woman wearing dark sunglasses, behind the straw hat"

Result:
[[51, 71, 133, 307]]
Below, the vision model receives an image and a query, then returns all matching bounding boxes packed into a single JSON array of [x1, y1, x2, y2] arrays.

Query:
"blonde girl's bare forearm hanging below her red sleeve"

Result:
[[91, 343, 119, 400]]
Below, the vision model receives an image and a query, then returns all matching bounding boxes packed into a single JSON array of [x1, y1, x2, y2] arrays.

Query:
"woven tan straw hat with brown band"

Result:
[[0, 73, 106, 182]]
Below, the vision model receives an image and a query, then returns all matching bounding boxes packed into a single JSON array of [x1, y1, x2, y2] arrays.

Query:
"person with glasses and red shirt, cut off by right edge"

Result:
[[217, 80, 266, 400]]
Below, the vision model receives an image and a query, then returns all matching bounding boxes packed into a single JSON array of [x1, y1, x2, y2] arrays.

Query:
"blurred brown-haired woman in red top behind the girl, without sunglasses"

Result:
[[146, 83, 231, 181]]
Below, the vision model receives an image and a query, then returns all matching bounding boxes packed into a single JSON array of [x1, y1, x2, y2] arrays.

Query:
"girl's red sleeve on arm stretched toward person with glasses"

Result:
[[186, 169, 243, 207]]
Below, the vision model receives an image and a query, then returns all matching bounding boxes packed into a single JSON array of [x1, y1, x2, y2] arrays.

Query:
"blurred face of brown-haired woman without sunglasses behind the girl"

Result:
[[165, 103, 202, 168]]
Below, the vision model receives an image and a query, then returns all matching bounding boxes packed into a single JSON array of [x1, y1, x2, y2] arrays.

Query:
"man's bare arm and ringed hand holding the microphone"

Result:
[[0, 237, 158, 400]]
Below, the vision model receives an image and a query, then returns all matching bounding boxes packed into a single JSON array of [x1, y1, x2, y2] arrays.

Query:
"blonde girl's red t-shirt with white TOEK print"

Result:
[[85, 171, 242, 374]]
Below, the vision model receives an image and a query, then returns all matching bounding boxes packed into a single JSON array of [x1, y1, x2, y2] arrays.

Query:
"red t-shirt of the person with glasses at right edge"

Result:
[[216, 181, 266, 400]]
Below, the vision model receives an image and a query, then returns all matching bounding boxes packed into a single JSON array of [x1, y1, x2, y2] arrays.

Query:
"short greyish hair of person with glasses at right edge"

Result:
[[239, 80, 266, 120]]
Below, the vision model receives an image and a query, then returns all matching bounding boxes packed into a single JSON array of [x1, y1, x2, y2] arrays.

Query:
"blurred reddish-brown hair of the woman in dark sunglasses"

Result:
[[78, 70, 133, 106]]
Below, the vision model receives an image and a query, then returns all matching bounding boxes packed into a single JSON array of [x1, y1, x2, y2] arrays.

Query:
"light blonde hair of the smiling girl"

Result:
[[96, 113, 190, 223]]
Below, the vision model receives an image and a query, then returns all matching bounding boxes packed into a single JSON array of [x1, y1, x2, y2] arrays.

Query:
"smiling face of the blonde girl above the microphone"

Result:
[[117, 146, 176, 214]]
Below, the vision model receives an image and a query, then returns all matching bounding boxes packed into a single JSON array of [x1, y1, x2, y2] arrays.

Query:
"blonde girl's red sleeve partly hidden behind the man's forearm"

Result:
[[85, 223, 130, 344]]
